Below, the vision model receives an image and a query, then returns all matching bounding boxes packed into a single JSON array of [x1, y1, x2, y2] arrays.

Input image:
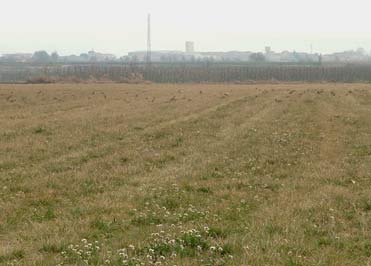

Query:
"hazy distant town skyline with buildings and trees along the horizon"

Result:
[[0, 45, 371, 64]]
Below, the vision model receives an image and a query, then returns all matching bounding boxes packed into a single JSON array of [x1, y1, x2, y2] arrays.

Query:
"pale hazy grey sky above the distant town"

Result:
[[0, 0, 371, 55]]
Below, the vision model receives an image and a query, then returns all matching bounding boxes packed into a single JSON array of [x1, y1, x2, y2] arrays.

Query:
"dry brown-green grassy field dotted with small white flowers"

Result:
[[0, 84, 371, 266]]
